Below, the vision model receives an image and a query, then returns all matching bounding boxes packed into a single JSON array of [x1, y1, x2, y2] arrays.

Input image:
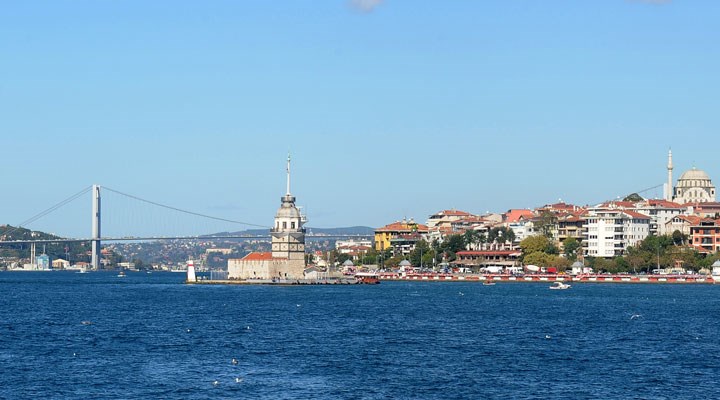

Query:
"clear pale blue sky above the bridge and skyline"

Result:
[[0, 0, 720, 236]]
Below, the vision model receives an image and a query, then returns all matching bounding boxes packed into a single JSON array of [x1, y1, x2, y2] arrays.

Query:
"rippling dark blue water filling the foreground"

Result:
[[0, 272, 720, 399]]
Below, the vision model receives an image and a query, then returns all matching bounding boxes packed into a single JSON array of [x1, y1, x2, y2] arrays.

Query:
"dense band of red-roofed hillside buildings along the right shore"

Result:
[[375, 199, 720, 258]]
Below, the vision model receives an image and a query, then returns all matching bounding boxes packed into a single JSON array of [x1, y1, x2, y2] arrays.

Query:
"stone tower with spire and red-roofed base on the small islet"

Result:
[[228, 156, 305, 282]]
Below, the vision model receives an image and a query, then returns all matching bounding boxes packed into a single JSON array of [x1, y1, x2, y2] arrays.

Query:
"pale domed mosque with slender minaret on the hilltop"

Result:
[[665, 150, 715, 204]]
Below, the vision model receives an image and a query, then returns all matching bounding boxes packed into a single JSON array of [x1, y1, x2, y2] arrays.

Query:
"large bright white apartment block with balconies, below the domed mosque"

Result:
[[583, 208, 651, 258]]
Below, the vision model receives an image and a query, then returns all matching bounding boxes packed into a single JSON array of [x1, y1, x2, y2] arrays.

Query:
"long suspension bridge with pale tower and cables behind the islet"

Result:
[[0, 185, 367, 269]]
